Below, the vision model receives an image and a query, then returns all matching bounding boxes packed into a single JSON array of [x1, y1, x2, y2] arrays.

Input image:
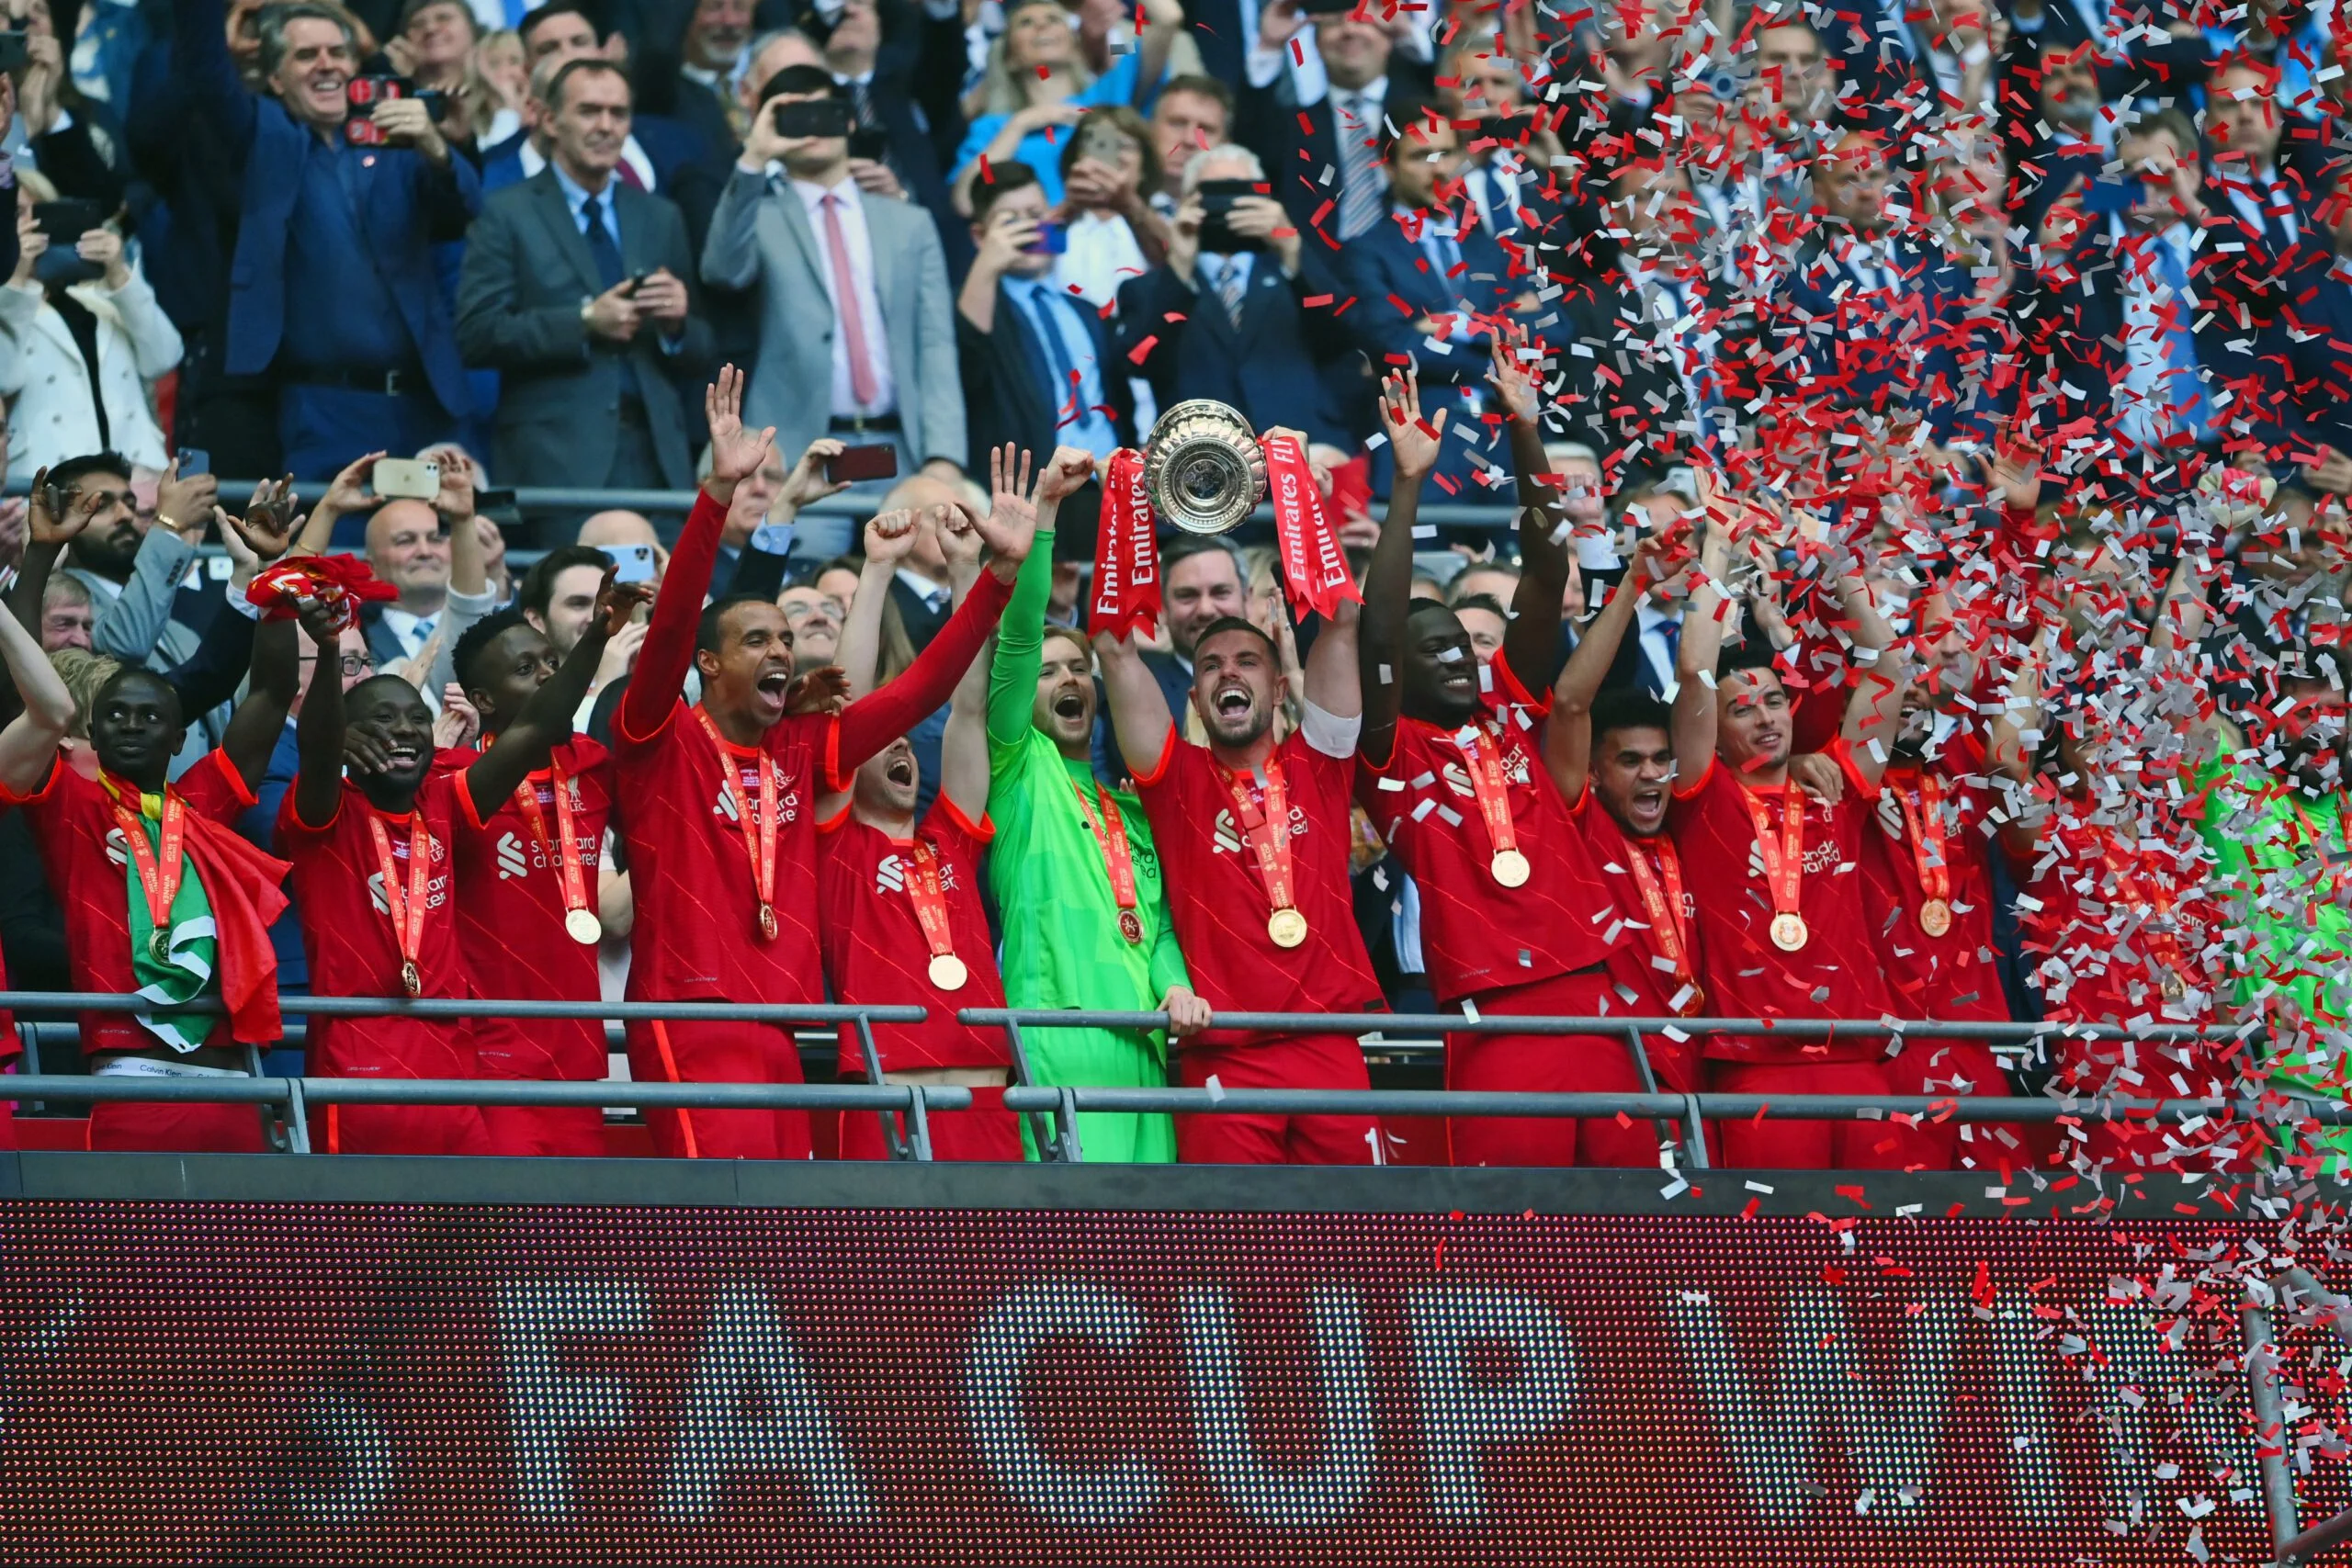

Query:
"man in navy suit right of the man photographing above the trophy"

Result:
[[1340, 101, 1557, 501]]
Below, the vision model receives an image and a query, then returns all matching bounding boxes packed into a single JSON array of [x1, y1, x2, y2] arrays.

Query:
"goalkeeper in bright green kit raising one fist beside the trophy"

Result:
[[988, 446, 1209, 1161]]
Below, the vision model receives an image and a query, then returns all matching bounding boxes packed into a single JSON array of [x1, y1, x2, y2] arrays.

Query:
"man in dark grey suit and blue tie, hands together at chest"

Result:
[[457, 59, 710, 489]]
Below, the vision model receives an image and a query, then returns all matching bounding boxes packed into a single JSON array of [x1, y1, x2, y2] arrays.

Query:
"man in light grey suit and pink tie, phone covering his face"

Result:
[[703, 66, 965, 555]]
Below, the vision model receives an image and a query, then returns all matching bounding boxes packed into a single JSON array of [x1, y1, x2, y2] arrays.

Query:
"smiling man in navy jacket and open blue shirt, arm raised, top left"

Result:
[[174, 0, 482, 479]]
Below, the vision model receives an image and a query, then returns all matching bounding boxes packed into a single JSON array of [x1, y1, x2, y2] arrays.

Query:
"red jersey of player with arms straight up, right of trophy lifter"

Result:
[[1357, 659, 1611, 1001]]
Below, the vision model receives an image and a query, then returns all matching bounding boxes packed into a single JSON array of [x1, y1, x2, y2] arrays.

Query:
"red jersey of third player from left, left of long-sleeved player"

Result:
[[452, 736, 612, 1079]]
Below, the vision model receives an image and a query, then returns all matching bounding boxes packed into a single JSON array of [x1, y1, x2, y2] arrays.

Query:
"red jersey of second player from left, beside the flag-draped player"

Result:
[[277, 773, 478, 1079]]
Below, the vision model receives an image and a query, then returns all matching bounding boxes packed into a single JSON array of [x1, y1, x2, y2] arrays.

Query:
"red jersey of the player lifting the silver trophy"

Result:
[[1136, 727, 1387, 1046]]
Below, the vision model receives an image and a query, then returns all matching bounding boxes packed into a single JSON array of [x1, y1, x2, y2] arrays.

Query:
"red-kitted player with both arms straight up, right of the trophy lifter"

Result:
[[1363, 355, 1658, 1166]]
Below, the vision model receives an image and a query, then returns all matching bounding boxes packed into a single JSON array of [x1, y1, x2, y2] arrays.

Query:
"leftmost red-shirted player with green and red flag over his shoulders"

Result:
[[0, 478, 297, 1155]]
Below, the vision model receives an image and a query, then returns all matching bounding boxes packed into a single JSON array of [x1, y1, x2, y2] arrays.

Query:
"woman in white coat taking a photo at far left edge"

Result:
[[0, 179, 181, 472]]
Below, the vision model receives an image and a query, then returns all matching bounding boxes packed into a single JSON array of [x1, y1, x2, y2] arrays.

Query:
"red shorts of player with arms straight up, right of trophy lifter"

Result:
[[1446, 971, 1658, 1166]]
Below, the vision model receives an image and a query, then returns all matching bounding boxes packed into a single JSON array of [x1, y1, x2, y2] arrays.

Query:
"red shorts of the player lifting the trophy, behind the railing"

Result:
[[1176, 1034, 1383, 1166]]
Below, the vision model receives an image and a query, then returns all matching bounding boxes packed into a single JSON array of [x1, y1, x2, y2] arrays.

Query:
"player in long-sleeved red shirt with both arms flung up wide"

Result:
[[612, 365, 1028, 1159]]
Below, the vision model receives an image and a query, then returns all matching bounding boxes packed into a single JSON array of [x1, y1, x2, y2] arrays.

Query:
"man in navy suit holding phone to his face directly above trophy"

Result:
[[1120, 143, 1352, 446]]
